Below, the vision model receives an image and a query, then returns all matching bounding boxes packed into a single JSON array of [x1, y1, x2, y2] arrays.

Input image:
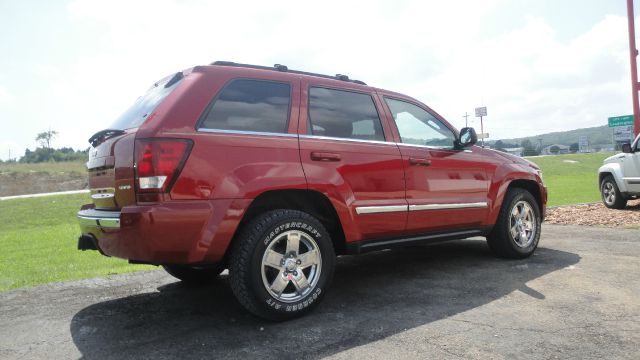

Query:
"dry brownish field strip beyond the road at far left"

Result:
[[0, 171, 88, 196]]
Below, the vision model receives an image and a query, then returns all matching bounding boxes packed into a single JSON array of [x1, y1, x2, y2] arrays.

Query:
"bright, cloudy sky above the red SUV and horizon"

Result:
[[0, 0, 631, 159]]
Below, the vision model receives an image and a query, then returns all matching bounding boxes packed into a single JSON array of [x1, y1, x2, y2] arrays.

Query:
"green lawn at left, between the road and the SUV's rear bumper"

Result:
[[0, 194, 155, 291]]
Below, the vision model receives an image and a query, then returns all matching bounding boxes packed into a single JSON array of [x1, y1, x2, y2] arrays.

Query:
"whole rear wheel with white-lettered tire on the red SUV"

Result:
[[229, 209, 335, 321]]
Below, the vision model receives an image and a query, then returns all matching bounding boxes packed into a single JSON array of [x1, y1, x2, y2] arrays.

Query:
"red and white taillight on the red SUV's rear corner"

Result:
[[135, 139, 192, 193]]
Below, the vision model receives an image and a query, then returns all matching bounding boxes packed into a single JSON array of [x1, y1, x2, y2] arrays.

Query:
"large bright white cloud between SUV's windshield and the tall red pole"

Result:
[[408, 16, 631, 139]]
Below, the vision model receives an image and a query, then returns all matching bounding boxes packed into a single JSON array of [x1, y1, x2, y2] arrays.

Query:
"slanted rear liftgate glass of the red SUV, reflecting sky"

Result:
[[110, 72, 183, 130]]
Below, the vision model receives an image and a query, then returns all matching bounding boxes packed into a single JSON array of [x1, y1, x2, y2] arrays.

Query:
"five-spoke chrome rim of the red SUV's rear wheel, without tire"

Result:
[[261, 230, 322, 303]]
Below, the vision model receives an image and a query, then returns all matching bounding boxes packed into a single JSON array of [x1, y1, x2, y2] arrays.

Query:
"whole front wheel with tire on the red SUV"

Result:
[[487, 188, 542, 259]]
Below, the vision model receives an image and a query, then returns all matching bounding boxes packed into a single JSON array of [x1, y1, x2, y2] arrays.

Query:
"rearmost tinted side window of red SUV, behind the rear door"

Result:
[[200, 79, 291, 133]]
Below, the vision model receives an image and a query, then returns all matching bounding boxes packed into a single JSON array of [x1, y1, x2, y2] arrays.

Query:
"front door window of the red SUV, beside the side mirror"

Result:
[[385, 98, 455, 148]]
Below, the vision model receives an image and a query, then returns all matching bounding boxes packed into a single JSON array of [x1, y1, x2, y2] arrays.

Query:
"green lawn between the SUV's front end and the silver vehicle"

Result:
[[527, 153, 615, 206]]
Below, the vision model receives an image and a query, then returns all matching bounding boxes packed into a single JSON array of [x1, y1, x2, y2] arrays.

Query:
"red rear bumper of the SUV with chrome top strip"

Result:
[[77, 201, 218, 264]]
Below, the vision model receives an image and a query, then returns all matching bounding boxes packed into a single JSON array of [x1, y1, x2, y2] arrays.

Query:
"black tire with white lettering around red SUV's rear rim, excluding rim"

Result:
[[249, 212, 335, 318]]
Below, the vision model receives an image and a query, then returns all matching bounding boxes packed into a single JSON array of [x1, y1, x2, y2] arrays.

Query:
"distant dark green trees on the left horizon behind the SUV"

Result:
[[0, 130, 89, 164]]
